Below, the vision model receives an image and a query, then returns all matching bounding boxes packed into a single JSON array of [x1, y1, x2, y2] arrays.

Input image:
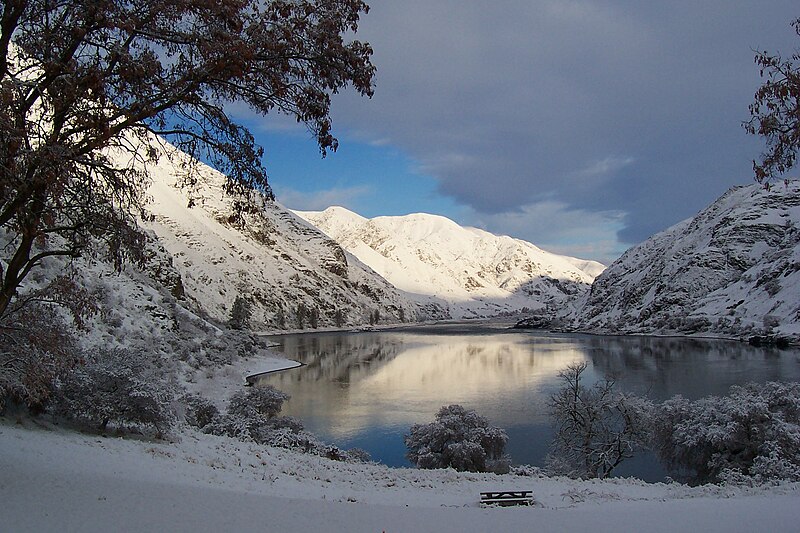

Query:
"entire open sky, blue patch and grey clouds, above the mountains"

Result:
[[239, 0, 800, 264]]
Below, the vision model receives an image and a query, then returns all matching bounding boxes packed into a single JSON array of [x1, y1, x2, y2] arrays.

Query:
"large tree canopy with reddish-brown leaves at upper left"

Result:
[[0, 0, 375, 317]]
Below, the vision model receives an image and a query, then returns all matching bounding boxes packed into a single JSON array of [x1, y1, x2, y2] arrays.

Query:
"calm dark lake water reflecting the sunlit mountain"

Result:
[[260, 324, 800, 481]]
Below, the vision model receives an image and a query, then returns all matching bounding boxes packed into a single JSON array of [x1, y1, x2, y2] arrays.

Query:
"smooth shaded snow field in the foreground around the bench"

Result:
[[0, 418, 800, 533]]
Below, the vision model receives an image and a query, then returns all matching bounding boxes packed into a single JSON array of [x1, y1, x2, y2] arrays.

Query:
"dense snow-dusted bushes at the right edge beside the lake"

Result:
[[654, 382, 800, 483]]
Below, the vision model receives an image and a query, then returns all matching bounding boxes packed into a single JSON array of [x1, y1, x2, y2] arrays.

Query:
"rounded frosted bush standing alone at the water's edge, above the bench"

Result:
[[404, 405, 510, 473]]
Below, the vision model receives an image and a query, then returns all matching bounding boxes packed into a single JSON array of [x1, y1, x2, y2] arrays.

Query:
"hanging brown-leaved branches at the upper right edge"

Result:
[[744, 18, 800, 185]]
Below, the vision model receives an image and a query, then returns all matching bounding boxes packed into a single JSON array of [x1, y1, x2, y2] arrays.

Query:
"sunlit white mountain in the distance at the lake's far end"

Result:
[[297, 207, 603, 318]]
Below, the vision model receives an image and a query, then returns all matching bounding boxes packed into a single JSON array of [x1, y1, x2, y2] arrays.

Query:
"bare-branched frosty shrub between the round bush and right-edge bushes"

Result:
[[547, 363, 653, 478]]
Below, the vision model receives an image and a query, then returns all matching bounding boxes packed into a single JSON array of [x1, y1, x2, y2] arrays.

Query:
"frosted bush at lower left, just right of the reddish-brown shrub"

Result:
[[54, 349, 175, 434]]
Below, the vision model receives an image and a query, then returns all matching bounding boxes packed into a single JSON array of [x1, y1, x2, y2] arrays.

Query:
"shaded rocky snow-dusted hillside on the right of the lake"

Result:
[[573, 182, 800, 339]]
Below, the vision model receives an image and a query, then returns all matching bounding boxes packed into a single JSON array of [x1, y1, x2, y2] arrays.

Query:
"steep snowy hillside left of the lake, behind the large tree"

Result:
[[114, 137, 443, 329]]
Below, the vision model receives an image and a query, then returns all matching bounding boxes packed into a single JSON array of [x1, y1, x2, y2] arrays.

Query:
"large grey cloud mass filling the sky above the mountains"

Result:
[[334, 0, 797, 243]]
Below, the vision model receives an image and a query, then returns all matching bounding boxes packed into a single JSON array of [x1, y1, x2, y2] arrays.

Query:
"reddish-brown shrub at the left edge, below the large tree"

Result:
[[0, 304, 78, 412]]
